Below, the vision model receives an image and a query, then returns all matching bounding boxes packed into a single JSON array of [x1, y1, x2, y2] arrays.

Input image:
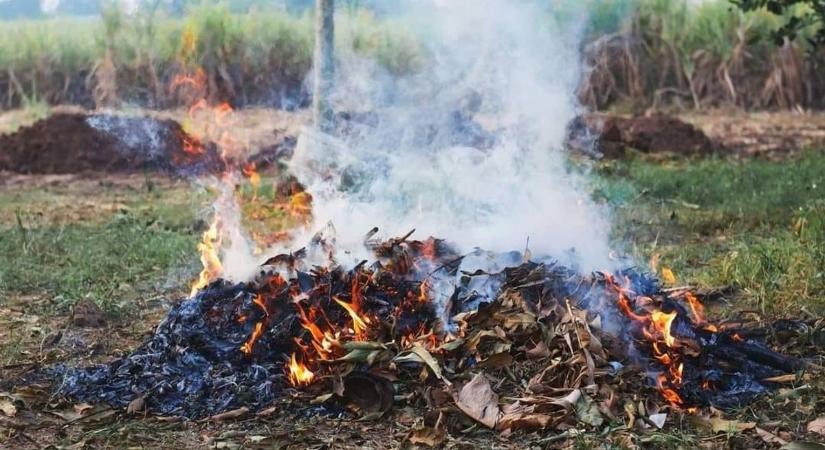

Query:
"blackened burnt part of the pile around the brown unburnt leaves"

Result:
[[51, 236, 802, 418]]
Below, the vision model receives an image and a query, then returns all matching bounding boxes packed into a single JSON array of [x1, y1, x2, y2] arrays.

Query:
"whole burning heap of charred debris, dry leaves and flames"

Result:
[[51, 229, 806, 430]]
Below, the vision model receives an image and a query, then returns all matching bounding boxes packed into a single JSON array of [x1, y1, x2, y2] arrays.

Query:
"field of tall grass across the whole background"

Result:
[[0, 0, 825, 112]]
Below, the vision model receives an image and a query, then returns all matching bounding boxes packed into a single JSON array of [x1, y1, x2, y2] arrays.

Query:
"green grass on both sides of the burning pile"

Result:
[[0, 153, 825, 320]]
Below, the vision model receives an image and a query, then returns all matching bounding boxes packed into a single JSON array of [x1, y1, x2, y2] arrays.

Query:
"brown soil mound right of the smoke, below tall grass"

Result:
[[568, 114, 719, 158]]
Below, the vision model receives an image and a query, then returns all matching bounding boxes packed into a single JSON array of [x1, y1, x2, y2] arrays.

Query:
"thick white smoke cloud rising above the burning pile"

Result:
[[290, 0, 610, 270]]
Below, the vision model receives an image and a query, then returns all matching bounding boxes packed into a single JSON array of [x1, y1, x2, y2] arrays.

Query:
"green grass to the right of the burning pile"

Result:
[[596, 153, 825, 314]]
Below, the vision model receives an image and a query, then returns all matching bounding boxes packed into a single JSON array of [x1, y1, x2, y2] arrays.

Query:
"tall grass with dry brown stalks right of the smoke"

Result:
[[581, 0, 825, 110]]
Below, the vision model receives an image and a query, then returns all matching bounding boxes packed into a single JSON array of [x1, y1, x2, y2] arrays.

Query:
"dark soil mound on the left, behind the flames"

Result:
[[0, 113, 224, 175]]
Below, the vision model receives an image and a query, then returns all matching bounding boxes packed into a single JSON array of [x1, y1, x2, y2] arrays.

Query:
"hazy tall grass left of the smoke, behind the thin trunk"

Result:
[[0, 3, 417, 108]]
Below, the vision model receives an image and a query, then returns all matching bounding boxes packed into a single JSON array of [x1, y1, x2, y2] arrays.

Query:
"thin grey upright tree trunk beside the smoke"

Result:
[[312, 0, 335, 133]]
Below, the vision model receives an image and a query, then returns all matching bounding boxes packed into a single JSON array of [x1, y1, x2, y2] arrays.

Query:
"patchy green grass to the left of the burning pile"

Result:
[[0, 178, 208, 315]]
